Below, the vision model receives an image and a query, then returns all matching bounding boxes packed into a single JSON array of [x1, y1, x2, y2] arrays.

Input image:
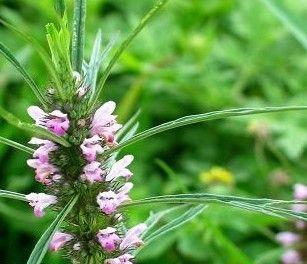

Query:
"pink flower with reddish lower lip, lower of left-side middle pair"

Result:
[[27, 159, 61, 185]]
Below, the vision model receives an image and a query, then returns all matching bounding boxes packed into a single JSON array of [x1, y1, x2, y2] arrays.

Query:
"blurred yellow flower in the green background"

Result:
[[199, 166, 235, 185]]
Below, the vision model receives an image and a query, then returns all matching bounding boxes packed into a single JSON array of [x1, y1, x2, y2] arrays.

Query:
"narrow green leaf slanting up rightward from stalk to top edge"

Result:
[[90, 0, 168, 111]]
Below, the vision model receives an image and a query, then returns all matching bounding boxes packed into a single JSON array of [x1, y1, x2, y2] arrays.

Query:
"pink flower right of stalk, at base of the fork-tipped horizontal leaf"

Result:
[[97, 182, 133, 215]]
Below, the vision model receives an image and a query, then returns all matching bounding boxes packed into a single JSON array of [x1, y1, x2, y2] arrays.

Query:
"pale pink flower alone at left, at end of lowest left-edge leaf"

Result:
[[26, 193, 57, 217]]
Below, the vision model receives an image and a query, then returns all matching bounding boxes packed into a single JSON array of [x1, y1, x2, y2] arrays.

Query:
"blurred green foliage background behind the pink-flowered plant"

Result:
[[0, 0, 307, 264]]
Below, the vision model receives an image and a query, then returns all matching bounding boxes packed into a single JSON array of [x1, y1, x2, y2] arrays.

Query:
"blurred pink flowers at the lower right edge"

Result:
[[276, 184, 307, 264]]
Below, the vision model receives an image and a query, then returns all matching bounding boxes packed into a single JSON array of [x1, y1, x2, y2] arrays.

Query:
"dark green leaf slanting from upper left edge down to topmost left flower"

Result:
[[0, 42, 47, 107]]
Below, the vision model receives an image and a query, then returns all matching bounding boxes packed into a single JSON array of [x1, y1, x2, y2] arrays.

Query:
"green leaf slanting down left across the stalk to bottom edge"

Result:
[[27, 196, 78, 264]]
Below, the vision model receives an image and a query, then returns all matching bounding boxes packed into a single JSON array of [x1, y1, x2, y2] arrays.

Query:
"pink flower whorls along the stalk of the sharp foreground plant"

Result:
[[26, 98, 147, 264]]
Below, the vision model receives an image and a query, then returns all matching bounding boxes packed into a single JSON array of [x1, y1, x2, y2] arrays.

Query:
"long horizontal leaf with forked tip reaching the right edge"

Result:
[[122, 193, 307, 221]]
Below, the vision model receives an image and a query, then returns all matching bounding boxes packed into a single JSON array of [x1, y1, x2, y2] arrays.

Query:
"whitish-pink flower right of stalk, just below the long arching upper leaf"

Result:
[[106, 155, 133, 181]]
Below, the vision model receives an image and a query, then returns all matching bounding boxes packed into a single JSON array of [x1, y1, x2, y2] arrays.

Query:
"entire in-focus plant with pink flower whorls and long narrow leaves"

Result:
[[0, 0, 307, 264]]
